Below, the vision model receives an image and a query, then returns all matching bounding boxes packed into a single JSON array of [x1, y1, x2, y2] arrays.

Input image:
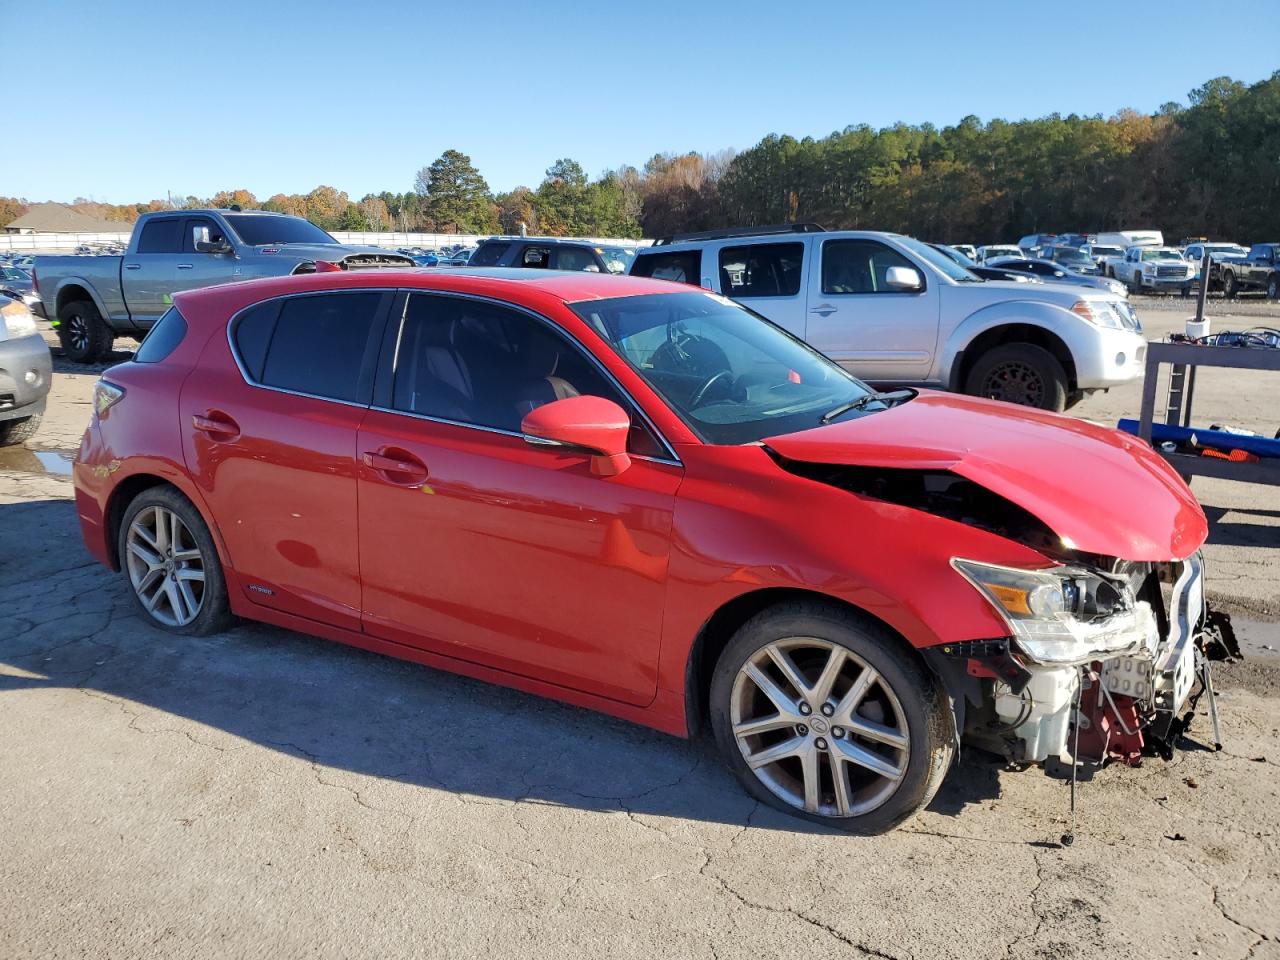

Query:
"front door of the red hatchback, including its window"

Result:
[[357, 293, 682, 704]]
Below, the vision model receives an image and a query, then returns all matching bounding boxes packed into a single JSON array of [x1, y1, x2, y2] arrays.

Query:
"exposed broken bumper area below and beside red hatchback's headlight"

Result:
[[929, 553, 1239, 765]]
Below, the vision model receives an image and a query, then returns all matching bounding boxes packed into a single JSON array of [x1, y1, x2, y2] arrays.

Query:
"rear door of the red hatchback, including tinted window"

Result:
[[179, 291, 394, 630]]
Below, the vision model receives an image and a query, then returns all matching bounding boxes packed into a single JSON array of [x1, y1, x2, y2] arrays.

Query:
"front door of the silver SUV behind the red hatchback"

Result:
[[806, 239, 941, 384]]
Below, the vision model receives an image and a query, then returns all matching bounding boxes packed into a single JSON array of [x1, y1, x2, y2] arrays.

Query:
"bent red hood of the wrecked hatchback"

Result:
[[764, 390, 1208, 561]]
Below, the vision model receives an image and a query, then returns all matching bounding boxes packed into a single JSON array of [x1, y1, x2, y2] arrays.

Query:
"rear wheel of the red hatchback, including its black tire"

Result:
[[118, 486, 232, 636]]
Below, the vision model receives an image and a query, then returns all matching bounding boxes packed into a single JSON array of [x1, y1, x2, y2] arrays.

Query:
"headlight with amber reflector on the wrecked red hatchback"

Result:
[[951, 558, 1157, 664]]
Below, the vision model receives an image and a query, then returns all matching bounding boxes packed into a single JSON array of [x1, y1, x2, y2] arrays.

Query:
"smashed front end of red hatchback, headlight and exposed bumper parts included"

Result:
[[932, 553, 1239, 765]]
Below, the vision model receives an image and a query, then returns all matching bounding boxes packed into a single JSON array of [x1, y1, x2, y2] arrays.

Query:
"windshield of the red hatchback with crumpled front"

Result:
[[570, 291, 886, 444]]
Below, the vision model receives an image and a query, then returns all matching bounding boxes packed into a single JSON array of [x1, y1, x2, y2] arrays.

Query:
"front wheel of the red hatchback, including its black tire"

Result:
[[710, 602, 955, 833]]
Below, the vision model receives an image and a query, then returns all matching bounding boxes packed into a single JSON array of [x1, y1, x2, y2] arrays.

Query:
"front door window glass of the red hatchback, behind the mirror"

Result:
[[392, 293, 667, 457]]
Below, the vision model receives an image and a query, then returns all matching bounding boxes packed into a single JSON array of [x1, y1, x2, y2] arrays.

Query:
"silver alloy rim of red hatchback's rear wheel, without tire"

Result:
[[125, 506, 205, 627]]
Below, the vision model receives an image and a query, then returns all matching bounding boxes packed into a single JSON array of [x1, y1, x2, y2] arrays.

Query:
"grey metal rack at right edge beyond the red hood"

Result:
[[1138, 343, 1280, 485]]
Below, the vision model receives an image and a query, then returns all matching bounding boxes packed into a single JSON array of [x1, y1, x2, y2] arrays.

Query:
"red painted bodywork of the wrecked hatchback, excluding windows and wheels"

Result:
[[74, 271, 1204, 735]]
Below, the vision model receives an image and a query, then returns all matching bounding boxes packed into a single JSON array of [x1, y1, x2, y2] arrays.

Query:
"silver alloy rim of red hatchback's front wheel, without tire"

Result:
[[730, 636, 910, 817]]
